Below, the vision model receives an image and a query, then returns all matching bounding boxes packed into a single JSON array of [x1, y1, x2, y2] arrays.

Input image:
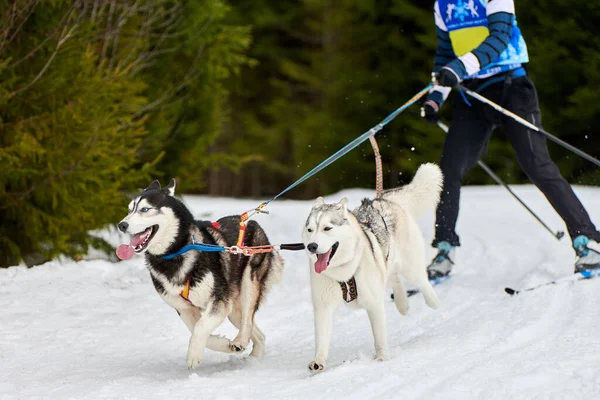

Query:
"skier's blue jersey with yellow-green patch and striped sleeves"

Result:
[[429, 0, 529, 105]]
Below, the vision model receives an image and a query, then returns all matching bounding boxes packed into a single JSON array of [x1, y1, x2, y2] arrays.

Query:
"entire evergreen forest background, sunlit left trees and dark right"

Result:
[[0, 0, 600, 266]]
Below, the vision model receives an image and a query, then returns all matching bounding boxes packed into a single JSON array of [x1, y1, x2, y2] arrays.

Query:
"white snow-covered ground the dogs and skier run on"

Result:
[[0, 186, 600, 399]]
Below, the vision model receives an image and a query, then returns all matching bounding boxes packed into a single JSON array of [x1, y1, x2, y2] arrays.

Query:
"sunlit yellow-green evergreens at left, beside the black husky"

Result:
[[0, 0, 248, 266]]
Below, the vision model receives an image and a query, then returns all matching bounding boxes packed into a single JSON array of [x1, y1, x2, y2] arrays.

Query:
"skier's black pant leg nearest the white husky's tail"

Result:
[[432, 97, 492, 246]]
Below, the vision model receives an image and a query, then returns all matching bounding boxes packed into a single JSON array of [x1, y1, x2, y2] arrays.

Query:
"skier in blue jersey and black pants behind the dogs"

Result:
[[422, 0, 600, 279]]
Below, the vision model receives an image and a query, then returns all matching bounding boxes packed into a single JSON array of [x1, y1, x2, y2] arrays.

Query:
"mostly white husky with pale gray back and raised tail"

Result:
[[302, 164, 443, 371]]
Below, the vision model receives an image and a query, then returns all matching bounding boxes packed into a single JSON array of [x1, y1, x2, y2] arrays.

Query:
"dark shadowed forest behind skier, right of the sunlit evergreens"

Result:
[[220, 0, 600, 197]]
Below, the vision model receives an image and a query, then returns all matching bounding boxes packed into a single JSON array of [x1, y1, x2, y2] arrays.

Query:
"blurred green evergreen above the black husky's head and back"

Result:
[[139, 0, 251, 192]]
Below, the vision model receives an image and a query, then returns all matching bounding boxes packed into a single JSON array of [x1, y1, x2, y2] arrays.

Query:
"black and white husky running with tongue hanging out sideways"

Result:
[[117, 180, 283, 368]]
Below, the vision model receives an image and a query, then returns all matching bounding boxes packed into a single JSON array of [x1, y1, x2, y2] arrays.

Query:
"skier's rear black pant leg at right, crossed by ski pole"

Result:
[[502, 77, 600, 241]]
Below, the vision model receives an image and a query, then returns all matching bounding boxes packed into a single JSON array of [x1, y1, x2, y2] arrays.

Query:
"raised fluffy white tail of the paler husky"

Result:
[[383, 163, 444, 217]]
